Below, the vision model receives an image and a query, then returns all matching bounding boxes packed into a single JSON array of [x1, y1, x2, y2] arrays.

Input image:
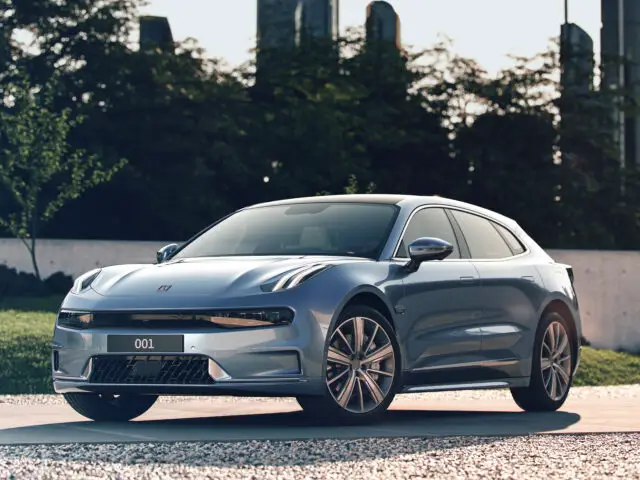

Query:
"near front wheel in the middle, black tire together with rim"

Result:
[[297, 305, 401, 424]]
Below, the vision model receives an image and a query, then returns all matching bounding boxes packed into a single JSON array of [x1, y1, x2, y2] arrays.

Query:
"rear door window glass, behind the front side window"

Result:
[[451, 210, 513, 259]]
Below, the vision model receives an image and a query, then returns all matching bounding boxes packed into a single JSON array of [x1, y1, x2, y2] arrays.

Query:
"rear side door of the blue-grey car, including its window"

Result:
[[450, 210, 544, 378]]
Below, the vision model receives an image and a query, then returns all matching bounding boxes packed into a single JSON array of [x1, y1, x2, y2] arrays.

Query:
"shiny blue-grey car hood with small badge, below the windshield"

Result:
[[91, 256, 367, 297]]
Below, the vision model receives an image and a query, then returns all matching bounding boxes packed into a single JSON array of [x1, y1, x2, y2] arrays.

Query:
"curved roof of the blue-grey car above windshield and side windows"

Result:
[[246, 193, 517, 226]]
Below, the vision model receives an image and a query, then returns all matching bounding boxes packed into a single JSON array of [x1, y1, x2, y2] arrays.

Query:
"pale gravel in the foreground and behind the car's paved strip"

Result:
[[0, 386, 640, 480]]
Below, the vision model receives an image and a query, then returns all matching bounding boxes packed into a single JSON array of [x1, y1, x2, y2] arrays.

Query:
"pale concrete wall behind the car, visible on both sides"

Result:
[[0, 239, 640, 351]]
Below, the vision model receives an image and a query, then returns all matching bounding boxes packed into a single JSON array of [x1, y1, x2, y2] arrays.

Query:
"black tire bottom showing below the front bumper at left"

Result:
[[63, 393, 158, 422]]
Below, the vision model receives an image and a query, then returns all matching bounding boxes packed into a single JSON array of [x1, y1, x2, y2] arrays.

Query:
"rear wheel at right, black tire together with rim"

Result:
[[511, 312, 578, 412]]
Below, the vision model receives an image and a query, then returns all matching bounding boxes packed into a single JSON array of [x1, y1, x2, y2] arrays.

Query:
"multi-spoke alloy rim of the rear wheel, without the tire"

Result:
[[540, 321, 571, 401]]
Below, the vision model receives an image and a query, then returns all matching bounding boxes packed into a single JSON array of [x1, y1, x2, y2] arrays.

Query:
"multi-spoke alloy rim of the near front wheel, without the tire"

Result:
[[326, 317, 396, 414]]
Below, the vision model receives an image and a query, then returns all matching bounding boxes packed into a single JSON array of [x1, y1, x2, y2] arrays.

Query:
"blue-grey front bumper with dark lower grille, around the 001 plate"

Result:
[[51, 314, 325, 396]]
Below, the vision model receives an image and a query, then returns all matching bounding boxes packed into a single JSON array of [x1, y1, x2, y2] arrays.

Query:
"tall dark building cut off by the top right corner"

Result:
[[601, 0, 640, 166]]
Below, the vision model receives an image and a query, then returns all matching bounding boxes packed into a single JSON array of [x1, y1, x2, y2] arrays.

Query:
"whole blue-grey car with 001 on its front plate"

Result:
[[52, 195, 582, 422]]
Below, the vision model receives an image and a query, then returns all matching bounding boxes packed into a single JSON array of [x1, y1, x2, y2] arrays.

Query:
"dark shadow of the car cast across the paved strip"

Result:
[[0, 410, 580, 458]]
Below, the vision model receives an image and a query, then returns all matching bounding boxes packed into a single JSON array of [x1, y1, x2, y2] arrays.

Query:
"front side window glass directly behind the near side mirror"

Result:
[[396, 208, 460, 258]]
